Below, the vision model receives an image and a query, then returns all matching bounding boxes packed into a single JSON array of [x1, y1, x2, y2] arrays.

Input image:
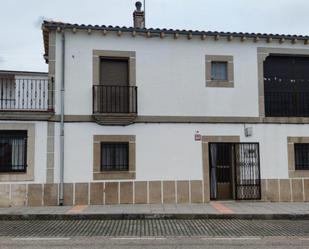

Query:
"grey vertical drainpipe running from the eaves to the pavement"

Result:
[[59, 30, 65, 206]]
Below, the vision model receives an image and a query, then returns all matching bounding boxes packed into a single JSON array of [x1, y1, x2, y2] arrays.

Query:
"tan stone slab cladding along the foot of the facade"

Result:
[[0, 179, 309, 207]]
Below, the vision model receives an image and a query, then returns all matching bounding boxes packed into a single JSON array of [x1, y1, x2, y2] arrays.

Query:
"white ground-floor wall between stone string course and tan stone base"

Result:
[[50, 123, 309, 182]]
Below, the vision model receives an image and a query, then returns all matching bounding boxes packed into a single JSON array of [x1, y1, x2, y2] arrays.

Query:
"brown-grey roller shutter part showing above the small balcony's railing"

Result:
[[100, 58, 129, 86]]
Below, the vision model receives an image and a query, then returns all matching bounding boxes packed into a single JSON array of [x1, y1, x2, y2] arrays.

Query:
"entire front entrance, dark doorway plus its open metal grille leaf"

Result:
[[209, 143, 261, 200]]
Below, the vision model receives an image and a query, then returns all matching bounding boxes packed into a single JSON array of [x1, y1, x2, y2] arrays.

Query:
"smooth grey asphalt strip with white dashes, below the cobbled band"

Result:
[[0, 237, 309, 249]]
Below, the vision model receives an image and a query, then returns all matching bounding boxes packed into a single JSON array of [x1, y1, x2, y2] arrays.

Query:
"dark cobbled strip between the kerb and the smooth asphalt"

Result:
[[0, 219, 309, 236]]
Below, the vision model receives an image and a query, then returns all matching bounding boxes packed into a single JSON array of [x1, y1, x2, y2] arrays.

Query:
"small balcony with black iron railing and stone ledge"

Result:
[[93, 85, 137, 125]]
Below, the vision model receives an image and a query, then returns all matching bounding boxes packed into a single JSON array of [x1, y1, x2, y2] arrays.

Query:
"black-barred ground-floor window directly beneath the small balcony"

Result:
[[101, 142, 129, 171]]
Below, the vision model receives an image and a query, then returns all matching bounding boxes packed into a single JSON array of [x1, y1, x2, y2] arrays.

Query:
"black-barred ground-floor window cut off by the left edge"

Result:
[[0, 130, 27, 173]]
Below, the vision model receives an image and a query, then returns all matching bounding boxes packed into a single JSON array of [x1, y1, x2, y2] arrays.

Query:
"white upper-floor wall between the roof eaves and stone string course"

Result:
[[51, 31, 305, 116]]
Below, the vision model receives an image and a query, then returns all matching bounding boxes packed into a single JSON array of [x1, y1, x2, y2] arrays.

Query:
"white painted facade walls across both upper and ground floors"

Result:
[[2, 27, 309, 188]]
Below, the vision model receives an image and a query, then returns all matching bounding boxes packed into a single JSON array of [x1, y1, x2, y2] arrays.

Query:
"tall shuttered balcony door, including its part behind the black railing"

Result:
[[99, 58, 130, 113]]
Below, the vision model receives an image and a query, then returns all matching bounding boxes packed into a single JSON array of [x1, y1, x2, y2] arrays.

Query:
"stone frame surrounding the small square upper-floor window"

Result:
[[205, 55, 234, 87]]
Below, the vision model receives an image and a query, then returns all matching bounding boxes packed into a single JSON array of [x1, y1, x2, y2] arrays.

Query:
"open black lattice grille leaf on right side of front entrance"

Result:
[[235, 143, 261, 200]]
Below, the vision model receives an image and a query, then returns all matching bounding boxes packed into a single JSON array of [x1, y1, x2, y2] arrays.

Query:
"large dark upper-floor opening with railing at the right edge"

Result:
[[264, 55, 309, 117]]
